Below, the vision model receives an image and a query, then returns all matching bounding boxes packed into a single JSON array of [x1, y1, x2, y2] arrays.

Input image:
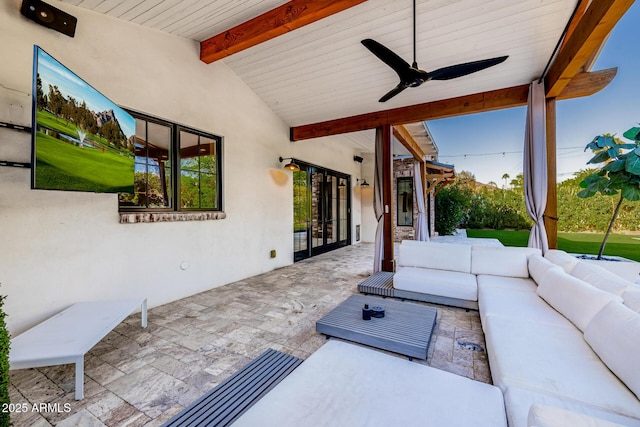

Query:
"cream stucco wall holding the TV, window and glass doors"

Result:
[[0, 0, 361, 334]]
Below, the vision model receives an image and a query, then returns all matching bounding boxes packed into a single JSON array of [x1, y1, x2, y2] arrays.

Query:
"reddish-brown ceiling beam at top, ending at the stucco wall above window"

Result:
[[200, 0, 366, 64]]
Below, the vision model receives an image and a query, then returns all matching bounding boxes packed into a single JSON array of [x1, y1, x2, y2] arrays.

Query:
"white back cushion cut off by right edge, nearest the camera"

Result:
[[584, 301, 640, 398]]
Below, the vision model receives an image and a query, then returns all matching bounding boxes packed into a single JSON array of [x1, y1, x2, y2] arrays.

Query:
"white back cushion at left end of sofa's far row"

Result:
[[398, 242, 471, 273]]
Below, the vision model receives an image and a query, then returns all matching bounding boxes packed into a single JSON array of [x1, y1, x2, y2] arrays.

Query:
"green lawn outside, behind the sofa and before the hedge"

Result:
[[467, 230, 640, 261]]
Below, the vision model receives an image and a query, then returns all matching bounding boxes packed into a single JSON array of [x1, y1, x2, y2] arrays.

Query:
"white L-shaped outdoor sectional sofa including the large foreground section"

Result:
[[224, 242, 640, 427]]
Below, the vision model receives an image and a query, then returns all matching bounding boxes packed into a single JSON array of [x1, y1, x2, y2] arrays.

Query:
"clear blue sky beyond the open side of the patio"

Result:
[[427, 3, 640, 187]]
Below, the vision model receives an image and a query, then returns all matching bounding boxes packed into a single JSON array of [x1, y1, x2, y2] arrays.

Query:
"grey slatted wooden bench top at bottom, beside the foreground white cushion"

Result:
[[162, 349, 302, 427]]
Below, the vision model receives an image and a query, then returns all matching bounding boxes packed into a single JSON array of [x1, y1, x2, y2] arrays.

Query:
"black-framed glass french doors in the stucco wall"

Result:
[[293, 162, 351, 261]]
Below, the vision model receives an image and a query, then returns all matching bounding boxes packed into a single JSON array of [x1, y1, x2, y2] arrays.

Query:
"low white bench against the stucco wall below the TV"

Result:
[[9, 299, 147, 400]]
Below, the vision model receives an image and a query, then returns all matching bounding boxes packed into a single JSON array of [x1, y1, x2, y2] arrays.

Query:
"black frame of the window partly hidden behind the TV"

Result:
[[118, 109, 224, 214]]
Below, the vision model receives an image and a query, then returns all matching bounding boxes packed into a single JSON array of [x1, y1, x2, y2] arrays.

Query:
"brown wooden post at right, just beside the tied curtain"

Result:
[[544, 98, 558, 249]]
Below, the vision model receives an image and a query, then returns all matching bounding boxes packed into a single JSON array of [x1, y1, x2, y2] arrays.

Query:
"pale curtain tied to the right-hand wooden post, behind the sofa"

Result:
[[524, 81, 549, 254]]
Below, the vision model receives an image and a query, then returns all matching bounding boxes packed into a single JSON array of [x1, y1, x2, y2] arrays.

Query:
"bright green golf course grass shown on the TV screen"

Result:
[[35, 132, 133, 193]]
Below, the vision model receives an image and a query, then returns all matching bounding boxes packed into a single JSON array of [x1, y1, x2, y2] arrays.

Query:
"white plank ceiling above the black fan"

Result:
[[63, 0, 577, 153]]
